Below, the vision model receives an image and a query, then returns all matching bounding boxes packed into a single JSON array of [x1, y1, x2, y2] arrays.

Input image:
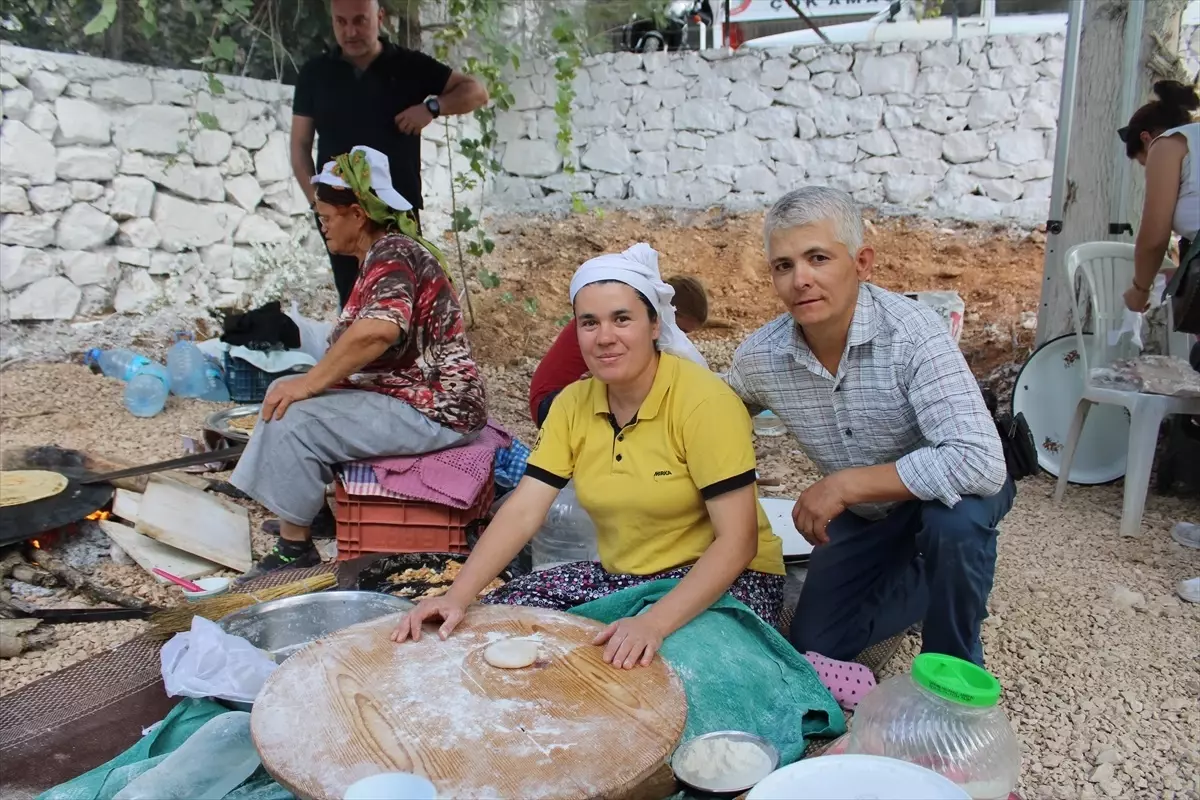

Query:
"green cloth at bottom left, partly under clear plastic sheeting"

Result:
[[37, 699, 292, 800]]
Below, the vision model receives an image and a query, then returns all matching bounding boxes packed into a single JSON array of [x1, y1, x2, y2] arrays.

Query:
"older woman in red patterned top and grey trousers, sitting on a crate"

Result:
[[230, 148, 487, 575]]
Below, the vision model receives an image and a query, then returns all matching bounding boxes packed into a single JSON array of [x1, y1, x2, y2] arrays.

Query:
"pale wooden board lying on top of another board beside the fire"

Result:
[[136, 475, 253, 572]]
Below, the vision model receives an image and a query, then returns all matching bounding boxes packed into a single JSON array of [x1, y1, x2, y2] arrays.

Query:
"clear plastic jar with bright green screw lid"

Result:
[[846, 652, 1021, 800]]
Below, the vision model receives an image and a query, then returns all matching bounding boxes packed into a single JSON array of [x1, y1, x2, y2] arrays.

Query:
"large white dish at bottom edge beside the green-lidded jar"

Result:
[[746, 756, 971, 800]]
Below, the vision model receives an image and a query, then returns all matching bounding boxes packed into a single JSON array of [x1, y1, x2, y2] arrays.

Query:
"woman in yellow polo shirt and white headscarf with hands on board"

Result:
[[392, 243, 784, 669]]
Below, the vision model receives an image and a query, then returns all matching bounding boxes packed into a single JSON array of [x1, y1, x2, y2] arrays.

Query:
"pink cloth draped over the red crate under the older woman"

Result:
[[365, 420, 512, 509]]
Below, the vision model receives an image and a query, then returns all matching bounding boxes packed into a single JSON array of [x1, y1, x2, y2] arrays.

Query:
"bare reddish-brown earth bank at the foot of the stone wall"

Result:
[[458, 210, 1043, 375]]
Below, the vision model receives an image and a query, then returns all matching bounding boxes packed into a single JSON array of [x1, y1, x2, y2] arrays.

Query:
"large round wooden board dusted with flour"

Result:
[[251, 606, 688, 800]]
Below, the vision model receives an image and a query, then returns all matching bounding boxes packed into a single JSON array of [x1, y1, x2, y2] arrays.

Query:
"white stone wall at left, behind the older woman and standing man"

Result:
[[0, 44, 478, 321]]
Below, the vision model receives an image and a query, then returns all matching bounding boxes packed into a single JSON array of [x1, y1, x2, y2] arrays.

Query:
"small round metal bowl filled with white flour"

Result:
[[671, 730, 779, 794]]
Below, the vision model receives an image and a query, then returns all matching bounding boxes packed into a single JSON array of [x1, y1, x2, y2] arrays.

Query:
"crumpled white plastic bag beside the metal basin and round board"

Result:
[[162, 616, 278, 703]]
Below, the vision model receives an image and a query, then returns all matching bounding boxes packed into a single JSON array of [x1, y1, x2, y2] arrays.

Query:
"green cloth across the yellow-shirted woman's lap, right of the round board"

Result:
[[571, 579, 846, 766]]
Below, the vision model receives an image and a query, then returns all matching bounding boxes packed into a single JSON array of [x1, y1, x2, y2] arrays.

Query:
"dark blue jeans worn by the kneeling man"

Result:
[[788, 479, 1016, 666]]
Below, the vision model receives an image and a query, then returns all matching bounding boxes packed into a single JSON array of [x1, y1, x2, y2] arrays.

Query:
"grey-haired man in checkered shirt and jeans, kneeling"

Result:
[[726, 187, 1016, 664]]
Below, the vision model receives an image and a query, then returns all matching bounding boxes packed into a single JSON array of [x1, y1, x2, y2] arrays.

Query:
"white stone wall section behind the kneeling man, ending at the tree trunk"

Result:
[[492, 35, 1063, 223]]
